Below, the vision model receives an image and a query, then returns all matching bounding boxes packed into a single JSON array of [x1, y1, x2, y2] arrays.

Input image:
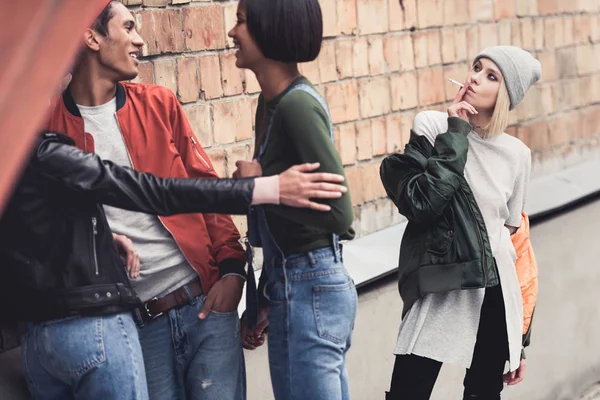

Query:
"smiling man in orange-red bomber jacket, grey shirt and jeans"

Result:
[[45, 1, 251, 400]]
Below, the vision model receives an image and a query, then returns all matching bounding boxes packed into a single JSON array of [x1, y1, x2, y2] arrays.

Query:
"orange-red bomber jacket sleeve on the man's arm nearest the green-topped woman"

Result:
[[166, 93, 246, 277]]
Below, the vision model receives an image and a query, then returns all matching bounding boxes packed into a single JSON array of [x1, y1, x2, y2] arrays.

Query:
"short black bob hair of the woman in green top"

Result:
[[246, 0, 323, 62]]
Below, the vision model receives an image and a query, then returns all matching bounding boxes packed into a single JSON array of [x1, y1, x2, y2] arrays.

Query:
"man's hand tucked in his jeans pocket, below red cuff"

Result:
[[198, 275, 244, 319]]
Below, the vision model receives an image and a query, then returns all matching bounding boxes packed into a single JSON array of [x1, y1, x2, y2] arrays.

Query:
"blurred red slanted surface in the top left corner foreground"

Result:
[[0, 0, 108, 213]]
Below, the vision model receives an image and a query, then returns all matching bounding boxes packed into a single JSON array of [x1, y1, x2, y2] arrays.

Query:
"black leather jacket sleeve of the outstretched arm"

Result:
[[33, 135, 254, 216]]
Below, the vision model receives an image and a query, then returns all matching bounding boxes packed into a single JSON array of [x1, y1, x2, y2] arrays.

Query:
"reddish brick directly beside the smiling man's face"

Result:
[[136, 10, 183, 55]]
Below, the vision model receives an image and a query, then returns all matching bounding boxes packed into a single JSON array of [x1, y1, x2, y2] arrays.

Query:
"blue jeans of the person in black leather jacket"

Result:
[[22, 313, 148, 400]]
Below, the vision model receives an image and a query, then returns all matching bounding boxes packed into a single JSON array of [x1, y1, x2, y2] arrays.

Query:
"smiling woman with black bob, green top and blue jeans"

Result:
[[229, 0, 357, 400]]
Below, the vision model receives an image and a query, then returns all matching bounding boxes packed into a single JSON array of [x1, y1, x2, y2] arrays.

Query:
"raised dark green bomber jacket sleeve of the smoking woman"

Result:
[[380, 117, 471, 223]]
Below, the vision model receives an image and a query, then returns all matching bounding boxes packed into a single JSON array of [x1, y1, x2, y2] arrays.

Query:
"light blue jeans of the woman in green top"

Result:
[[264, 247, 357, 400]]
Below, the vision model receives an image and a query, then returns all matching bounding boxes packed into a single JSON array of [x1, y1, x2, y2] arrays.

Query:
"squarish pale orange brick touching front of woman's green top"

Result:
[[213, 99, 252, 144]]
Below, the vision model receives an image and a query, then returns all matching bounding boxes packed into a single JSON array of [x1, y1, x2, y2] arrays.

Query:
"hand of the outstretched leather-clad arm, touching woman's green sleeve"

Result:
[[279, 163, 348, 211]]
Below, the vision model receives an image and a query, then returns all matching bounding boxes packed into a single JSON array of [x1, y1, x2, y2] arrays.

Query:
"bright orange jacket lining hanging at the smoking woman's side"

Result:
[[511, 213, 538, 342]]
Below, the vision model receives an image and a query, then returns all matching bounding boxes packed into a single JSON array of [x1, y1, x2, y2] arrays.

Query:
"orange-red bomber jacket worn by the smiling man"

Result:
[[45, 83, 245, 293]]
